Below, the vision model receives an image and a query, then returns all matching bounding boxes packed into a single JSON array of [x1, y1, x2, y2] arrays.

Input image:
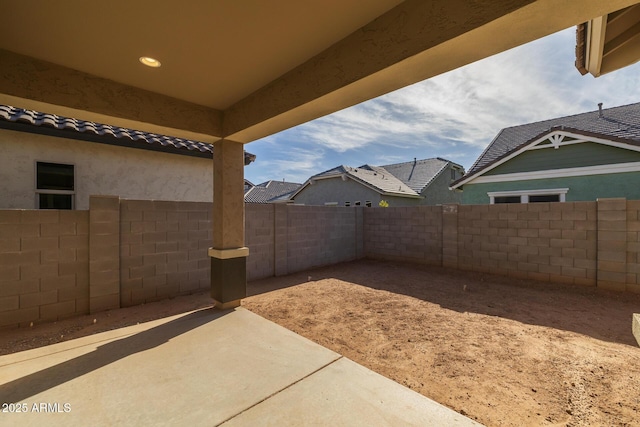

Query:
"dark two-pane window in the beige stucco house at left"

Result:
[[36, 162, 75, 209]]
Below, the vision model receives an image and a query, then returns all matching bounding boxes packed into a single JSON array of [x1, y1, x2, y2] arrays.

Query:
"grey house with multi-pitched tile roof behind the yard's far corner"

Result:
[[291, 158, 464, 207]]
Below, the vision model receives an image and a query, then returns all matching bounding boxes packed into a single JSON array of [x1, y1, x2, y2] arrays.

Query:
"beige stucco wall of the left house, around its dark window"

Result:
[[0, 129, 213, 210]]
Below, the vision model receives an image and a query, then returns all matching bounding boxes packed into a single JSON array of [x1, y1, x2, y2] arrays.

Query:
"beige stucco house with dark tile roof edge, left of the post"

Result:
[[0, 105, 255, 210]]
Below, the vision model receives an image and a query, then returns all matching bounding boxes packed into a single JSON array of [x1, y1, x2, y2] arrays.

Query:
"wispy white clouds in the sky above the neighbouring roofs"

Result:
[[300, 29, 640, 152]]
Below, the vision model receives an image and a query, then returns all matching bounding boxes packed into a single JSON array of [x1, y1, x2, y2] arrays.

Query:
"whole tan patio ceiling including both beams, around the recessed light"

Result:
[[0, 0, 638, 143]]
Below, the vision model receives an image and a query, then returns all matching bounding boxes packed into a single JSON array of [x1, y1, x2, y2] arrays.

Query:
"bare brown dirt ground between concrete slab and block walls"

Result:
[[0, 260, 640, 426]]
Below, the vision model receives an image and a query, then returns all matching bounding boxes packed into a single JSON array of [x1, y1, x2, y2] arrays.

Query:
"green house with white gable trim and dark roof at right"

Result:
[[452, 103, 640, 204]]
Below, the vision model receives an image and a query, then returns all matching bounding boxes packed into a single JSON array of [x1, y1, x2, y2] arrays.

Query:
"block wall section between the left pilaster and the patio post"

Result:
[[120, 200, 213, 307]]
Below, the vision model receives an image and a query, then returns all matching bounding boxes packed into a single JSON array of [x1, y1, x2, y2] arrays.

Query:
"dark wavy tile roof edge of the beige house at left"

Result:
[[0, 105, 255, 164]]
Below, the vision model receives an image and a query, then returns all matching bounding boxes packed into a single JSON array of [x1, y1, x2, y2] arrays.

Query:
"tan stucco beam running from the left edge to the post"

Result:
[[0, 49, 222, 142]]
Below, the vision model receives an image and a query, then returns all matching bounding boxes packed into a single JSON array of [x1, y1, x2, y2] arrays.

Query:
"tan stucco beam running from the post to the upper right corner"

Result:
[[224, 0, 637, 142]]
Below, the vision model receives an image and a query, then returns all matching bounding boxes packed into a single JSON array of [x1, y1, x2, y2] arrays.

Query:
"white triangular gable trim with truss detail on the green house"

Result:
[[451, 130, 640, 189]]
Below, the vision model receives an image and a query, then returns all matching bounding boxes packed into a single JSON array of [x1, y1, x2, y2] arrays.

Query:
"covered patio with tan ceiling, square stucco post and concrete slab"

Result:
[[0, 0, 638, 425]]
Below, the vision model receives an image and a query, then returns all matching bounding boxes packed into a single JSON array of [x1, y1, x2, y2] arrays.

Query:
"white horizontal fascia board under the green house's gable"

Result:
[[473, 162, 640, 184]]
